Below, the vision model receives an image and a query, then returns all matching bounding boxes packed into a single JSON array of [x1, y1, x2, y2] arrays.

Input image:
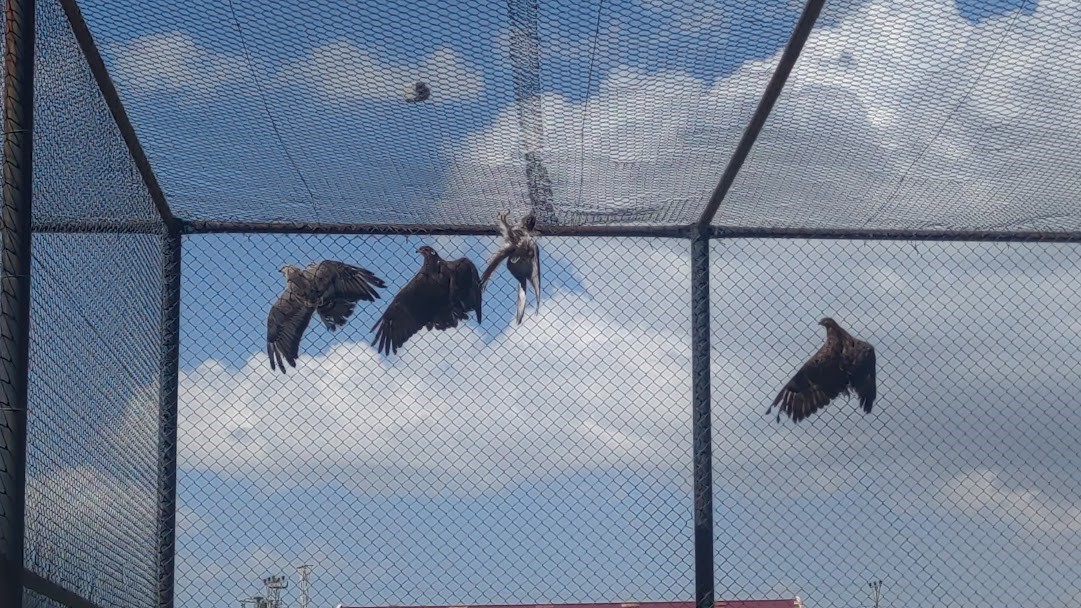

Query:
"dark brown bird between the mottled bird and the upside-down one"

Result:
[[372, 244, 482, 355]]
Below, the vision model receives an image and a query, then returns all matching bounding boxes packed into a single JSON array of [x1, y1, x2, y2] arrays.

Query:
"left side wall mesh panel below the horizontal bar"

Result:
[[25, 229, 161, 608]]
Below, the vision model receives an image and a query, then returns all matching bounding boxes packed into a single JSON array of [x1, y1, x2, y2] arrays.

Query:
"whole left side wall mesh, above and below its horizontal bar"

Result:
[[13, 2, 161, 608]]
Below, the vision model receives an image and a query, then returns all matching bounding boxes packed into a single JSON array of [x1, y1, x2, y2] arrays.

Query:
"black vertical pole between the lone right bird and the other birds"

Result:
[[691, 228, 716, 608]]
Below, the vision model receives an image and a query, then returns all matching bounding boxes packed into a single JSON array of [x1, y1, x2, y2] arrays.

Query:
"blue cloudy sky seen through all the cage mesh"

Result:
[[19, 0, 1081, 608]]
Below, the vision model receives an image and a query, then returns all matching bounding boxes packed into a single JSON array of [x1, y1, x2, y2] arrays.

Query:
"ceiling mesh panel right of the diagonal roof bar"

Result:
[[716, 0, 1081, 230]]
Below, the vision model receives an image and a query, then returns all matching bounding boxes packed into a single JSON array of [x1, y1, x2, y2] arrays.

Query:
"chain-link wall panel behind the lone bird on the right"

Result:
[[712, 240, 1081, 607]]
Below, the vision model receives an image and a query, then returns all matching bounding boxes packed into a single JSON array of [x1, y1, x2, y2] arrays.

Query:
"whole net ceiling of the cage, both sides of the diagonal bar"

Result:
[[65, 0, 1081, 232]]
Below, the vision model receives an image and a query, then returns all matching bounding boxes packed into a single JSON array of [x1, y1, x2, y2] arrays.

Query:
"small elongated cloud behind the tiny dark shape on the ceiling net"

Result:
[[278, 40, 484, 103]]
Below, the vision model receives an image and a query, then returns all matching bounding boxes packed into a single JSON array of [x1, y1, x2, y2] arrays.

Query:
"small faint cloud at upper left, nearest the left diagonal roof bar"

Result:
[[108, 31, 251, 96]]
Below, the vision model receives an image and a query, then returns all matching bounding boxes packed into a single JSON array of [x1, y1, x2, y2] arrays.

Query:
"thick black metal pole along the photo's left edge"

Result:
[[0, 0, 36, 608]]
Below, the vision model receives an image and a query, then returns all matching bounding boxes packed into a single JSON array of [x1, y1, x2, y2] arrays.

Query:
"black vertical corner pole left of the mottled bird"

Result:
[[158, 222, 183, 608]]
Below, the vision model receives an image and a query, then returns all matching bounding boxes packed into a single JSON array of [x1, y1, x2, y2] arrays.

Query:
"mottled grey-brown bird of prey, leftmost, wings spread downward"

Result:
[[267, 260, 386, 373]]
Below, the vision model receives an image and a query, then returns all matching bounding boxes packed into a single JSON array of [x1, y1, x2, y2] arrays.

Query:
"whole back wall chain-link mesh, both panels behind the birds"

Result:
[[177, 236, 1081, 607]]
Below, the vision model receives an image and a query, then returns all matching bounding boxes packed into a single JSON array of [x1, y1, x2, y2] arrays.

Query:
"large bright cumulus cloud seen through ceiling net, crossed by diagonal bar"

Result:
[[450, 0, 1081, 229]]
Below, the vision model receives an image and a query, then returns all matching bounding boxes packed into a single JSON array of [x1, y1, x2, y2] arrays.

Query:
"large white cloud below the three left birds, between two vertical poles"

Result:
[[179, 235, 690, 493]]
